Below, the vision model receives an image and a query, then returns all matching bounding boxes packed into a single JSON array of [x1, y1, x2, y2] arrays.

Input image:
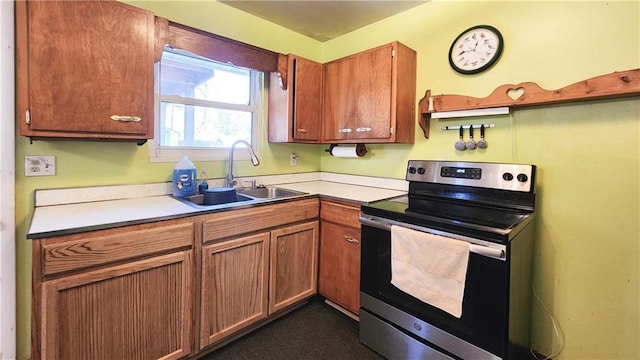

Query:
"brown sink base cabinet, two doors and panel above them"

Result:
[[200, 199, 319, 349]]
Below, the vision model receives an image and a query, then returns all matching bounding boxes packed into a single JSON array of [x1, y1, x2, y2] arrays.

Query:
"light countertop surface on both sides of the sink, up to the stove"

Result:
[[27, 175, 406, 239]]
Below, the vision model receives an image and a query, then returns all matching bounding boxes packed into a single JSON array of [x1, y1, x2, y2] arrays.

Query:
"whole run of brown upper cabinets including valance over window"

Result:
[[15, 1, 416, 144]]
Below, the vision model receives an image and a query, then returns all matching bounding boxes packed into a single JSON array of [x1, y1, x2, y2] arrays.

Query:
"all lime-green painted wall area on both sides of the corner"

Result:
[[16, 0, 640, 359]]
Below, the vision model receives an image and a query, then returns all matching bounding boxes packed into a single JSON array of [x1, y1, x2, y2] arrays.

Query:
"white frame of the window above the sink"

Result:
[[148, 49, 266, 162]]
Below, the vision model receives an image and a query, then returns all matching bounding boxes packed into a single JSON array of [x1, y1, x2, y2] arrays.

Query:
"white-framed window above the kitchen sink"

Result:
[[150, 48, 263, 161]]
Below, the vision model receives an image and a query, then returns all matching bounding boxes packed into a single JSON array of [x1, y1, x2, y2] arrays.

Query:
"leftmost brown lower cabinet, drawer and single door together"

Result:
[[32, 220, 194, 359]]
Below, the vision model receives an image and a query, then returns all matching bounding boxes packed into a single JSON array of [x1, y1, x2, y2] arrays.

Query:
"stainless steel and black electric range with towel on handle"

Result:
[[359, 160, 536, 360]]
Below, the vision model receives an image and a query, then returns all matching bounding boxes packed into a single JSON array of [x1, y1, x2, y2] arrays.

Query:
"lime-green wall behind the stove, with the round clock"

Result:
[[321, 1, 640, 359]]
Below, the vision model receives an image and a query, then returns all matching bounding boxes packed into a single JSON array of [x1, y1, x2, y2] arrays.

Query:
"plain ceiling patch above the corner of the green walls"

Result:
[[219, 0, 429, 41]]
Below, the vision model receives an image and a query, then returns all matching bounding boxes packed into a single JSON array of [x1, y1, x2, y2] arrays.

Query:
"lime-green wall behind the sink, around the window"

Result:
[[16, 1, 321, 359]]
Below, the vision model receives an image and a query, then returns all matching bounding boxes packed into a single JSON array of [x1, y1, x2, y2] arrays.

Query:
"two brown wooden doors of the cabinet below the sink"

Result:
[[200, 219, 319, 348]]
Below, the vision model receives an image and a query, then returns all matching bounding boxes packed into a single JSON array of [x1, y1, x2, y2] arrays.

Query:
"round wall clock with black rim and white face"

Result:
[[449, 25, 504, 74]]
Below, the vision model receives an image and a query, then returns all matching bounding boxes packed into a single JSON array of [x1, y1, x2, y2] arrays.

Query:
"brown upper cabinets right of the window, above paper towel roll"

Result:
[[269, 42, 416, 143]]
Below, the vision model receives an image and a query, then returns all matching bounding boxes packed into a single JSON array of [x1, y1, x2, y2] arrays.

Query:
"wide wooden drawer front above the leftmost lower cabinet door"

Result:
[[40, 219, 194, 275]]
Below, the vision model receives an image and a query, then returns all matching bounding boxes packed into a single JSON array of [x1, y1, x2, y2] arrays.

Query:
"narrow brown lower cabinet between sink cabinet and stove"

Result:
[[318, 200, 360, 314]]
